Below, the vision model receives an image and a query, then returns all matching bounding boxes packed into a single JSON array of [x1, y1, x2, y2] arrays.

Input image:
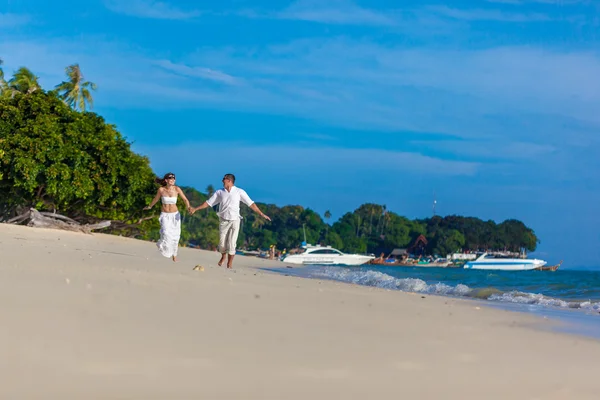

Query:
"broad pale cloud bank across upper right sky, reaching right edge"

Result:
[[177, 38, 600, 142]]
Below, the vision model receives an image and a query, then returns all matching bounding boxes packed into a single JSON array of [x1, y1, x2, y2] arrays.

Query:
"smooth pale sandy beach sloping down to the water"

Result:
[[0, 224, 600, 400]]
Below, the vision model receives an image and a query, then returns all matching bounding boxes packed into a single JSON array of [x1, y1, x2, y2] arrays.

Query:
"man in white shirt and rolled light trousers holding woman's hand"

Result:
[[191, 174, 271, 268]]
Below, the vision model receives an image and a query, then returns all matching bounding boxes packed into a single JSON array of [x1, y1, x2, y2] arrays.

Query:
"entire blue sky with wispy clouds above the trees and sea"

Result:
[[0, 0, 600, 268]]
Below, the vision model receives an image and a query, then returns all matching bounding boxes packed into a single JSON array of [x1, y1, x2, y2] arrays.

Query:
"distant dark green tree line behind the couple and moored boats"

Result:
[[170, 186, 539, 256]]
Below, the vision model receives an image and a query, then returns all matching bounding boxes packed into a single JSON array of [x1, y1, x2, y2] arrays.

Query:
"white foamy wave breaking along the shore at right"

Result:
[[310, 267, 600, 312]]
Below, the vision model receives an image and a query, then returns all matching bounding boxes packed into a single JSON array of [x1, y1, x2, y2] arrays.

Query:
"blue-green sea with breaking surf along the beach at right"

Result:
[[278, 265, 600, 338]]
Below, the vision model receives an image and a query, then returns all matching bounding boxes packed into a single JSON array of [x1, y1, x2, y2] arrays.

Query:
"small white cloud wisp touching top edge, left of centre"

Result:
[[104, 0, 200, 20]]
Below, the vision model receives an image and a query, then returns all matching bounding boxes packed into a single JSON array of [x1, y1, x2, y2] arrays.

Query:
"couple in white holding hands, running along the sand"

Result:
[[144, 173, 271, 268]]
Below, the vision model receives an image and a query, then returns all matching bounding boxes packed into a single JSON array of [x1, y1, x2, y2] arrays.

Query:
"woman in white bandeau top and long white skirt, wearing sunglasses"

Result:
[[144, 172, 190, 262]]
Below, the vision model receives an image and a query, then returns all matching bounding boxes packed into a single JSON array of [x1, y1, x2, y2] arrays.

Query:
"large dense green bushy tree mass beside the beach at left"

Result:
[[0, 90, 156, 222]]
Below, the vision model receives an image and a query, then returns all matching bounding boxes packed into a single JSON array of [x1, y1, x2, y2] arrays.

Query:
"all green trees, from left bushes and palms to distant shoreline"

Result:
[[0, 60, 539, 256]]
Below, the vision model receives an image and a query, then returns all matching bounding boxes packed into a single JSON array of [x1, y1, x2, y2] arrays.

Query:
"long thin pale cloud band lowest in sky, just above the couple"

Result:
[[136, 142, 480, 192]]
